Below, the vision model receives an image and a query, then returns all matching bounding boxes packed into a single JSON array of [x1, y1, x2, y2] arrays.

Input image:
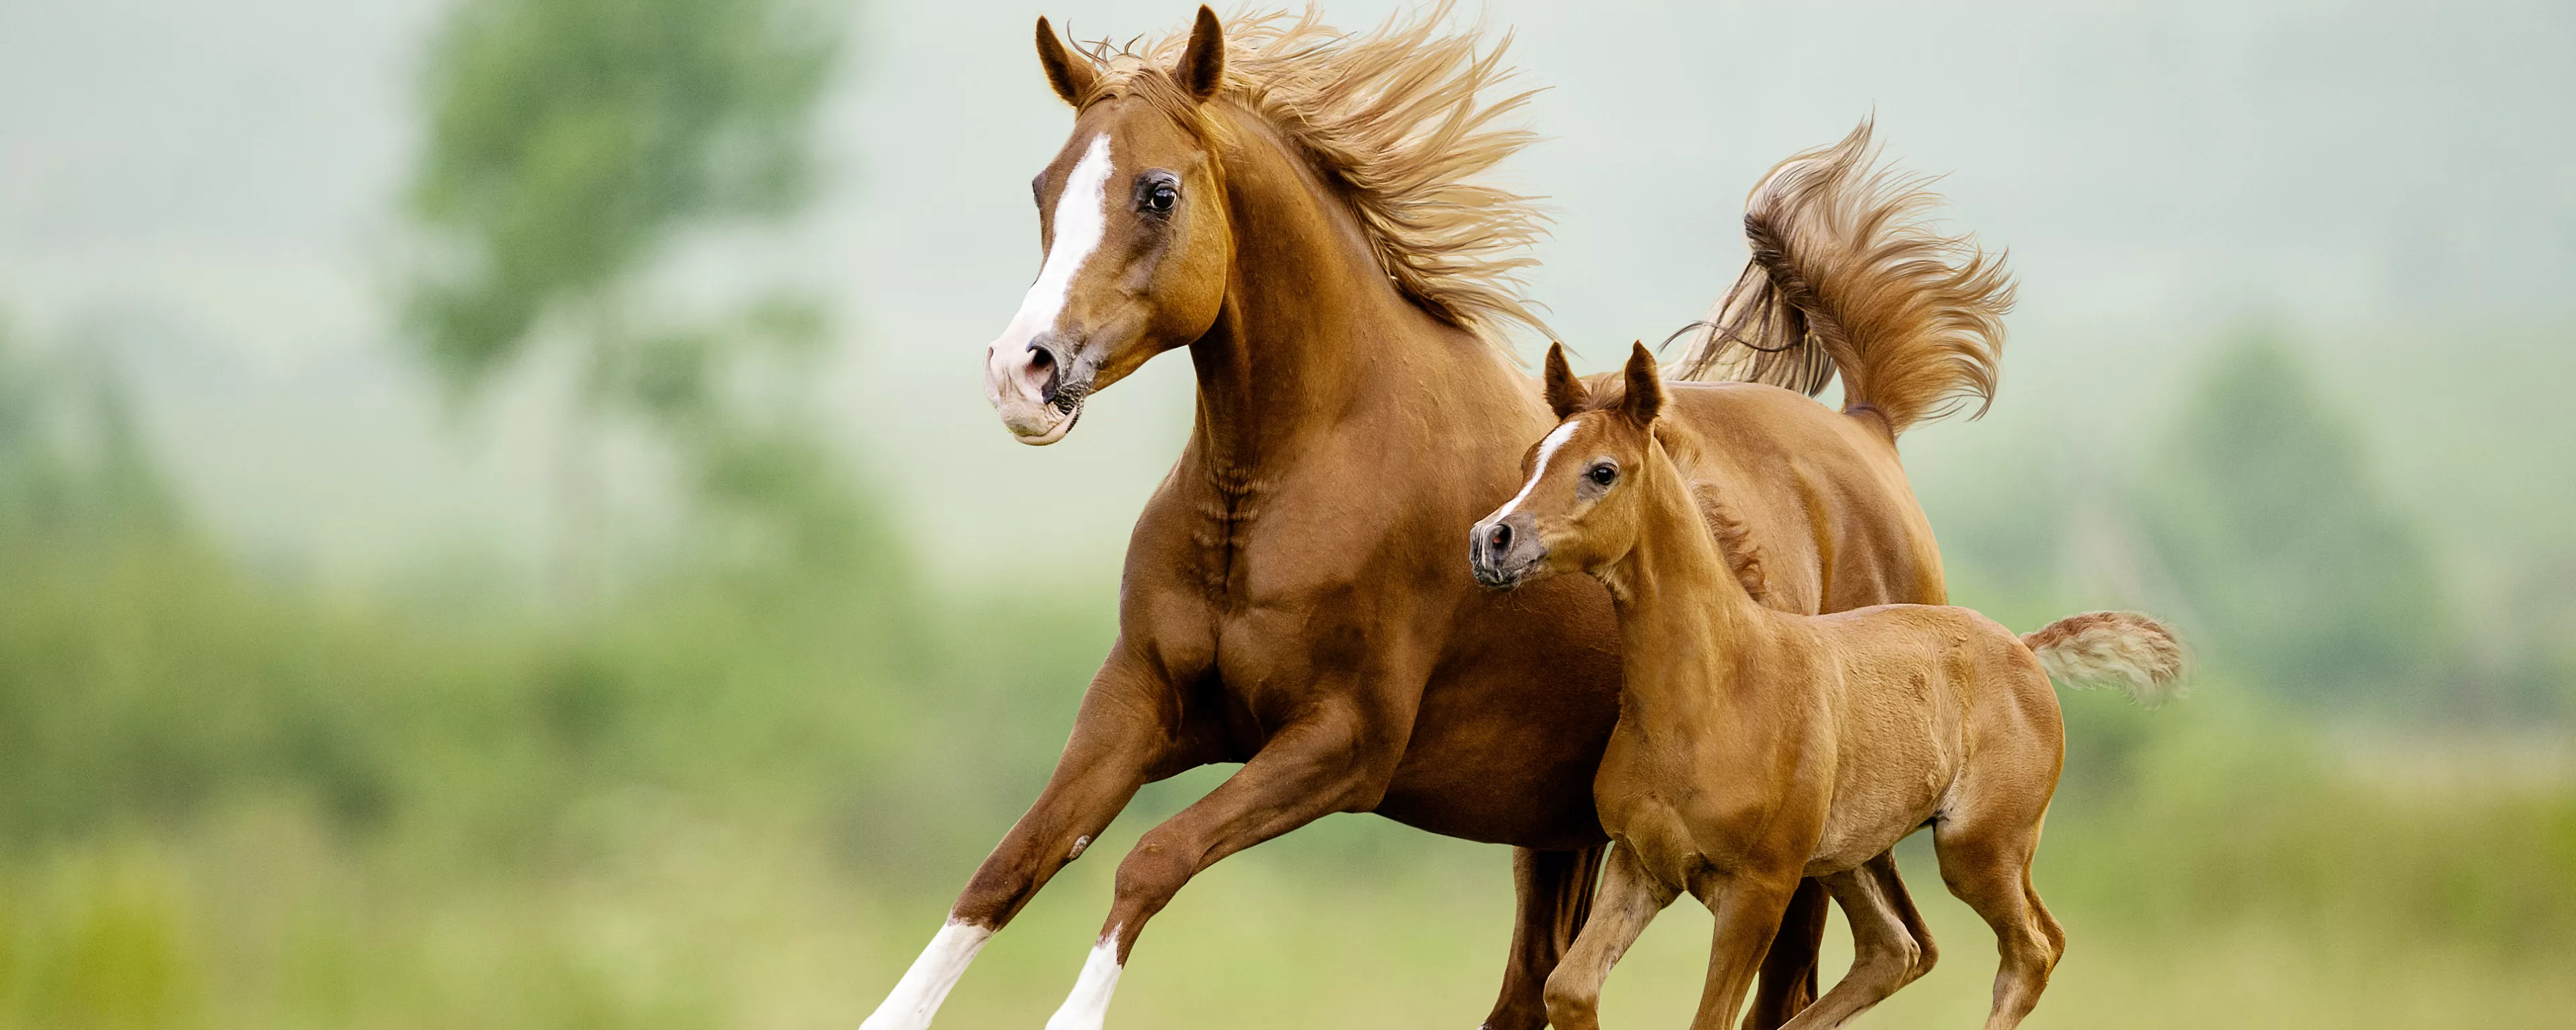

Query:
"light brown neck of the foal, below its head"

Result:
[[1597, 445, 1767, 732]]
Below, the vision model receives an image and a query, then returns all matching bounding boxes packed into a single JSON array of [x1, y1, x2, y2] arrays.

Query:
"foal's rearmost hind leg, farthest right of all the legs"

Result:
[[1932, 808, 2066, 1030]]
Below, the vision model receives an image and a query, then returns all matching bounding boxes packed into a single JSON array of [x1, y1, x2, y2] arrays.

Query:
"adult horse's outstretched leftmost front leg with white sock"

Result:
[[861, 641, 1195, 1030]]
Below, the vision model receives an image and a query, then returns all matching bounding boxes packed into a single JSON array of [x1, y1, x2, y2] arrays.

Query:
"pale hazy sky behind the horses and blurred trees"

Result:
[[0, 0, 2576, 592]]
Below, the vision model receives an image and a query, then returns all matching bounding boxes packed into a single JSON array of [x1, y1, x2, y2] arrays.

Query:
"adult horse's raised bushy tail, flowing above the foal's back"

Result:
[[1674, 121, 2012, 438]]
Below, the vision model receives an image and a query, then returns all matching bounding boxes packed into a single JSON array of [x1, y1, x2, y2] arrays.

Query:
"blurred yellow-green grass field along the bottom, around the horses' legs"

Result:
[[0, 651, 2576, 1027]]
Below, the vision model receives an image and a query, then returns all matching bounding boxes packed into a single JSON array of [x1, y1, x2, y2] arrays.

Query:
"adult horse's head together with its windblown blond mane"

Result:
[[984, 0, 1546, 443]]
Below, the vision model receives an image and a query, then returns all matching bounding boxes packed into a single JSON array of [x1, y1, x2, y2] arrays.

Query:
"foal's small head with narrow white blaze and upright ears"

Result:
[[1468, 343, 1680, 587]]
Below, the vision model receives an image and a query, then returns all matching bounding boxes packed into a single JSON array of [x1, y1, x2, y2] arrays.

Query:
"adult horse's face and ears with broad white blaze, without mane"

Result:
[[984, 8, 1234, 443]]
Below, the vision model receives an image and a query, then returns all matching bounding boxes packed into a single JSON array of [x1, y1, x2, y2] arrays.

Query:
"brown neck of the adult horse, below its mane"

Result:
[[1190, 111, 1491, 490]]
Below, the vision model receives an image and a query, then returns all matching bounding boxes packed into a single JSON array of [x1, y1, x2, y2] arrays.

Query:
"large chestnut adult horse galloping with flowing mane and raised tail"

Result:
[[865, 5, 2009, 1030]]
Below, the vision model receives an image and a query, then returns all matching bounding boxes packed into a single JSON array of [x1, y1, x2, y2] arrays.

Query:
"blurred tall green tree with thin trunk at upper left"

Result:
[[407, 0, 837, 605]]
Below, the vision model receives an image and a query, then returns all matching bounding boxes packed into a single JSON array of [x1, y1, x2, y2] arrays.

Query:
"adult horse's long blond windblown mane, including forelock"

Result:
[[1077, 0, 1548, 345]]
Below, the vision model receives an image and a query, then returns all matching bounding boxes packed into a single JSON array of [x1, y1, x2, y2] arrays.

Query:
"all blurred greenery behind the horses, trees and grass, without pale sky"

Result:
[[0, 0, 2576, 1030]]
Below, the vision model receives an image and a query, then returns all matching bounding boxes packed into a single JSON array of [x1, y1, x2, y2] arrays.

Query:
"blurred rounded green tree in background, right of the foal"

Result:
[[2141, 335, 2460, 711]]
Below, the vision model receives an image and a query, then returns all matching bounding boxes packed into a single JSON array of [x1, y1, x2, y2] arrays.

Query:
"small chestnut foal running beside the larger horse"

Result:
[[1468, 343, 2182, 1030]]
